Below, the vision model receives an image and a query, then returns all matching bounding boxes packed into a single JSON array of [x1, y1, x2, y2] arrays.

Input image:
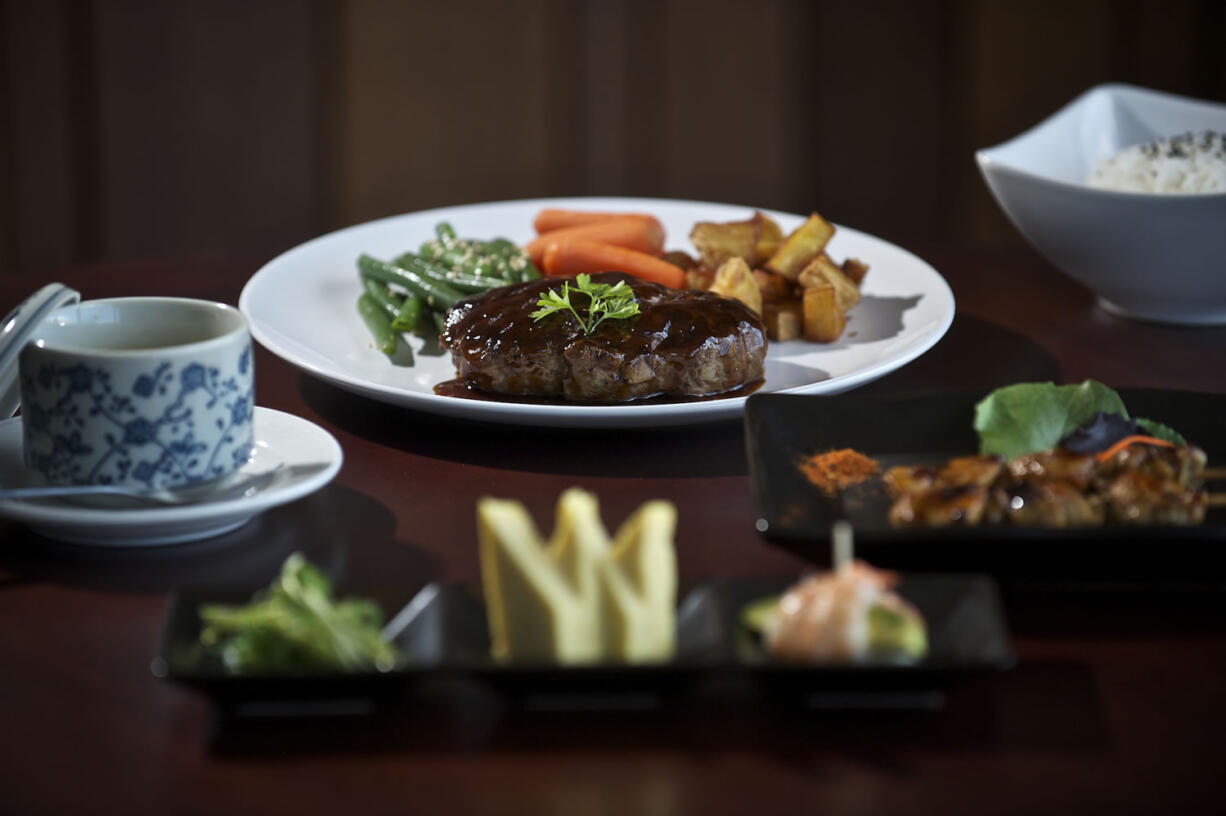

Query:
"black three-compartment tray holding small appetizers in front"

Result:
[[153, 575, 1014, 714]]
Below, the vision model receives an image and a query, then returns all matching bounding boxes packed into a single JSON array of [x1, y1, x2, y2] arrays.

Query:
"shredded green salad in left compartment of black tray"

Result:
[[199, 553, 397, 674]]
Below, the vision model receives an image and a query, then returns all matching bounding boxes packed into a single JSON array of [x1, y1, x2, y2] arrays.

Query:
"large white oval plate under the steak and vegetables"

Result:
[[239, 198, 954, 428]]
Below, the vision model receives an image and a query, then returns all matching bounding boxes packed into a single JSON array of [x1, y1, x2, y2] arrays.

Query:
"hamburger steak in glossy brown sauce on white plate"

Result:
[[441, 272, 766, 402]]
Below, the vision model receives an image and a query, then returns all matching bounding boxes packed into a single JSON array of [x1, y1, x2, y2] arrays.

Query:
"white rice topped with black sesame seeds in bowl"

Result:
[[1089, 130, 1226, 194]]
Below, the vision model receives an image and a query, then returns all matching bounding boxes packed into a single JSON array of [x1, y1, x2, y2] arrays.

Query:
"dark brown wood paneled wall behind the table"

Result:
[[0, 0, 1226, 273]]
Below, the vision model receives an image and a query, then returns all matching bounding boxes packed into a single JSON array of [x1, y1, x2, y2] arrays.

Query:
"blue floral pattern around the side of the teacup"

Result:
[[22, 343, 255, 488]]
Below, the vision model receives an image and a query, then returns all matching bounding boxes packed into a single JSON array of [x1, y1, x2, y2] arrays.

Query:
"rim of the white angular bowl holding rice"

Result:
[[975, 82, 1226, 199]]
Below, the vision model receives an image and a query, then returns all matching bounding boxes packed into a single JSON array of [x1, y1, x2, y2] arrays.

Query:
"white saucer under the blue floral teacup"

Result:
[[0, 407, 343, 546]]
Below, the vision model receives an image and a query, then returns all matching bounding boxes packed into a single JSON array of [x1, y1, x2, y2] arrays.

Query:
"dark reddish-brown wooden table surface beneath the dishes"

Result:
[[0, 246, 1226, 815]]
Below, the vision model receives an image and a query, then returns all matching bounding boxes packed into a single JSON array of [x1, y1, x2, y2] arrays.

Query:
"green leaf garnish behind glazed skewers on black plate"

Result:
[[975, 380, 1186, 459]]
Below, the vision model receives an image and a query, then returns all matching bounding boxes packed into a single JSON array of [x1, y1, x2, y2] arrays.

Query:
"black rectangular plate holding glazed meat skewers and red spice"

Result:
[[745, 388, 1226, 570]]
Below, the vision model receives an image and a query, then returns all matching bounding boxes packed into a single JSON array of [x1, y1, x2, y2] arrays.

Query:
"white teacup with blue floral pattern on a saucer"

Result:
[[18, 298, 255, 489]]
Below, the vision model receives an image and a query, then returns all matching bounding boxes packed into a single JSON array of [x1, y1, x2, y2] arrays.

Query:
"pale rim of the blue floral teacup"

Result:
[[29, 297, 249, 358]]
